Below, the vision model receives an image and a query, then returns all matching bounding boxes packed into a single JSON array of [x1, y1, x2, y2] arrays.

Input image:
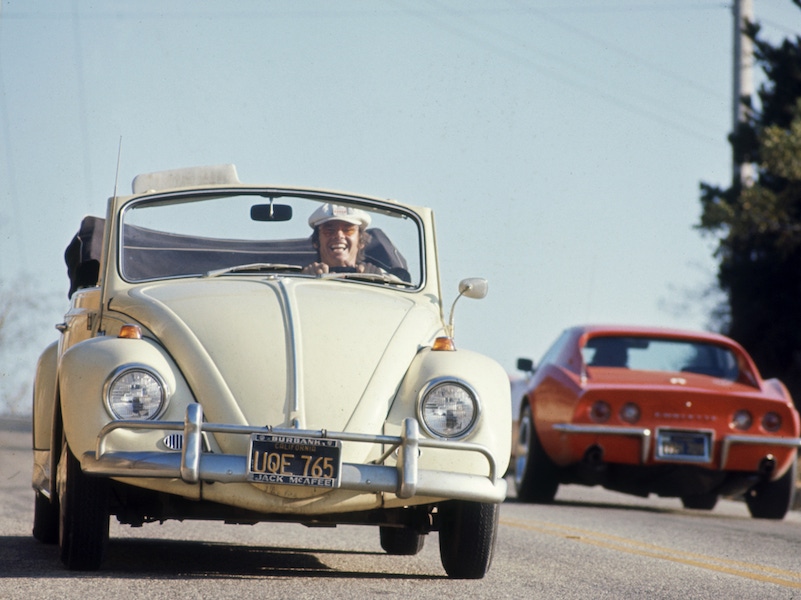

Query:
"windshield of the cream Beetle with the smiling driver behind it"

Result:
[[119, 190, 424, 289]]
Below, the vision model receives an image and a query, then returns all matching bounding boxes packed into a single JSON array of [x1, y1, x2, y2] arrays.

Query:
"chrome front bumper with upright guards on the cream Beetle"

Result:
[[81, 404, 506, 503]]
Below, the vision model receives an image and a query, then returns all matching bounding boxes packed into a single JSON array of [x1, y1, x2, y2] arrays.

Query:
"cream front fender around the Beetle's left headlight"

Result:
[[59, 337, 193, 456]]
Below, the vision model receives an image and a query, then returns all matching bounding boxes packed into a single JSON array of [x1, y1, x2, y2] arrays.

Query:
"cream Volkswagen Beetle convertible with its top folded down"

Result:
[[33, 165, 511, 578]]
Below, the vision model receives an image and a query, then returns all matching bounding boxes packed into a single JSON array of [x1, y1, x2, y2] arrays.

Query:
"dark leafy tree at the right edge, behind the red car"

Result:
[[699, 0, 801, 406]]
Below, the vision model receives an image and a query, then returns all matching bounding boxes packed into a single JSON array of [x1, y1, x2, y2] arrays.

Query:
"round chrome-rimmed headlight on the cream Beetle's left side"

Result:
[[106, 368, 167, 420]]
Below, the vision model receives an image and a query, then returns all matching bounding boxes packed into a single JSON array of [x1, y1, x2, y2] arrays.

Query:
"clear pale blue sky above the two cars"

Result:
[[0, 0, 801, 412]]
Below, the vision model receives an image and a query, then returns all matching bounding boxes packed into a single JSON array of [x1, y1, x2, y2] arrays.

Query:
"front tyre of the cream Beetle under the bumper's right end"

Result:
[[437, 500, 500, 579]]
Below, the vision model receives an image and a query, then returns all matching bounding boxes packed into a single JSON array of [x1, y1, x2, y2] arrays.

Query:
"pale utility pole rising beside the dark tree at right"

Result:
[[732, 0, 756, 187]]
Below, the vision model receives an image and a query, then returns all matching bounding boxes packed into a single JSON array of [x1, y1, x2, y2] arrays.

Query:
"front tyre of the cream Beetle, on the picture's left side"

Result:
[[58, 441, 109, 571]]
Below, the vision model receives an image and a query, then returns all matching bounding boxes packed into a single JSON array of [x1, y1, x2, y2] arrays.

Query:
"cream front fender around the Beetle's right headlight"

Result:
[[386, 348, 512, 475]]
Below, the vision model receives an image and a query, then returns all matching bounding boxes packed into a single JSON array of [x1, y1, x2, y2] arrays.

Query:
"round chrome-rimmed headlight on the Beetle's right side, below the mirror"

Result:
[[420, 381, 479, 439]]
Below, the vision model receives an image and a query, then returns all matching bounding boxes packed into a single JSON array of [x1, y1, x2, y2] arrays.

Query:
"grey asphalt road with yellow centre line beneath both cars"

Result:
[[0, 419, 801, 600]]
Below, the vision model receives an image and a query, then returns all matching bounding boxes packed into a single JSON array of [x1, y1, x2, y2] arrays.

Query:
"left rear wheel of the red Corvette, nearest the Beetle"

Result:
[[515, 405, 559, 504]]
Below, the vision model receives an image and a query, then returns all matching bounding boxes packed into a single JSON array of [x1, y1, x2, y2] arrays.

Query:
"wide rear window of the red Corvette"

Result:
[[581, 336, 739, 381]]
